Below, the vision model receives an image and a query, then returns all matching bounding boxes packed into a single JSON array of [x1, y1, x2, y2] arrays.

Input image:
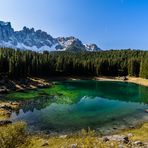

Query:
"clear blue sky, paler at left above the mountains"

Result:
[[0, 0, 148, 50]]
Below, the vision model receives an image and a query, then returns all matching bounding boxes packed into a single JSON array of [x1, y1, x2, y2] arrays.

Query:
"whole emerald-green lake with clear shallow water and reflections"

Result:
[[9, 80, 148, 134]]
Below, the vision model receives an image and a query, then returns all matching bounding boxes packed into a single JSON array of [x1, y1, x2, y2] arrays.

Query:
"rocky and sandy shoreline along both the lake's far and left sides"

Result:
[[0, 76, 148, 120]]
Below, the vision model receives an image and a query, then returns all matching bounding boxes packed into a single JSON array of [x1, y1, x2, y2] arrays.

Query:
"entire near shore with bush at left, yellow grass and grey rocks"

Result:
[[0, 122, 148, 148]]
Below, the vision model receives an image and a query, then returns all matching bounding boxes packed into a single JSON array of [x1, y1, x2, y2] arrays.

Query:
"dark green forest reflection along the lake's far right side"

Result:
[[65, 81, 148, 104]]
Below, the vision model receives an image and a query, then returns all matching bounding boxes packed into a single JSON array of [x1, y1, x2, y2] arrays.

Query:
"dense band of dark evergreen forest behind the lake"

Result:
[[0, 48, 148, 79]]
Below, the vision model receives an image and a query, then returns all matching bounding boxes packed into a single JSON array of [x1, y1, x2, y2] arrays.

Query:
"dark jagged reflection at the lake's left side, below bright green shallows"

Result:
[[20, 96, 55, 113]]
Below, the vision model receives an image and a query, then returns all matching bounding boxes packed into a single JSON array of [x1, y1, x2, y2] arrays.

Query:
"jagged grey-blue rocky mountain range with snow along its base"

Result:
[[0, 21, 101, 52]]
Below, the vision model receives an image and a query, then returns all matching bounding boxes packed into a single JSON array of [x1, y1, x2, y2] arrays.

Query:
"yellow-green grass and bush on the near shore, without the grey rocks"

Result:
[[0, 122, 148, 148]]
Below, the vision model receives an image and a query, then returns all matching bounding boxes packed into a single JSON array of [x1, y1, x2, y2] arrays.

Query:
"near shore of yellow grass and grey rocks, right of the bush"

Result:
[[22, 124, 148, 148]]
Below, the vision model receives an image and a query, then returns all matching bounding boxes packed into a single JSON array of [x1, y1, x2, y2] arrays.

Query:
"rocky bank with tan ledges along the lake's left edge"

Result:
[[0, 76, 52, 126]]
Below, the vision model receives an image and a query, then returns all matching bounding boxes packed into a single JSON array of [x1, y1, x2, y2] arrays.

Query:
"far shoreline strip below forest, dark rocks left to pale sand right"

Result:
[[0, 76, 148, 94]]
